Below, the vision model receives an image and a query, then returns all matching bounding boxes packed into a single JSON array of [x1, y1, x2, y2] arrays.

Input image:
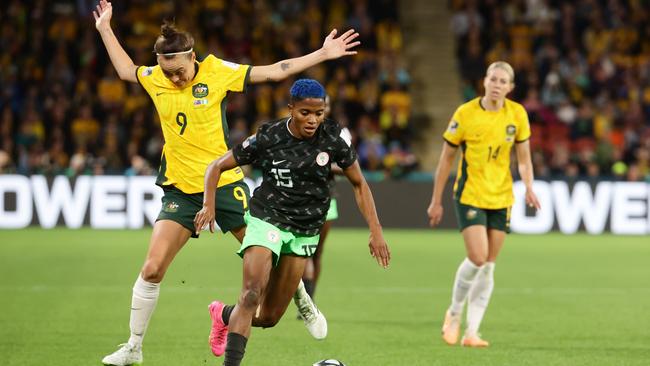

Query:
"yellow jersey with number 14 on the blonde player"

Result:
[[443, 97, 530, 209]]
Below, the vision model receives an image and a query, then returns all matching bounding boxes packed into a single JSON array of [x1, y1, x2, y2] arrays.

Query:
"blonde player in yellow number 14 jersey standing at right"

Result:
[[427, 61, 540, 347]]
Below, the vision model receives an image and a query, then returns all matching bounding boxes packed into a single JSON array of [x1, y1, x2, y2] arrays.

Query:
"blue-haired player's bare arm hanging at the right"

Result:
[[343, 161, 390, 268]]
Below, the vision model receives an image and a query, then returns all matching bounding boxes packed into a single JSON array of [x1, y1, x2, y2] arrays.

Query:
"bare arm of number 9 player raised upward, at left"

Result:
[[93, 0, 138, 83]]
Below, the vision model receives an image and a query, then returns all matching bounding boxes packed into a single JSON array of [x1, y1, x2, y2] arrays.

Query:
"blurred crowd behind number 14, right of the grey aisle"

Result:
[[450, 0, 650, 182]]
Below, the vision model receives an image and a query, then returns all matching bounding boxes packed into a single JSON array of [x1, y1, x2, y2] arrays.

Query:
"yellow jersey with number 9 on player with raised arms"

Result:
[[136, 55, 251, 193]]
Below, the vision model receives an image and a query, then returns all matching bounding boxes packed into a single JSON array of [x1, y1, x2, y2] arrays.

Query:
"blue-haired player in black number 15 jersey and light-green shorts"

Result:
[[194, 79, 390, 366]]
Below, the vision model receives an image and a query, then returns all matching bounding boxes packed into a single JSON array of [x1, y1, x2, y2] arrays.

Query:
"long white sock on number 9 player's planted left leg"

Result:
[[129, 275, 160, 348]]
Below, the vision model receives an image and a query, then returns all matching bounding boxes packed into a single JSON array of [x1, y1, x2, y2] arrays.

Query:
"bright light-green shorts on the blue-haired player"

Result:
[[237, 211, 320, 266]]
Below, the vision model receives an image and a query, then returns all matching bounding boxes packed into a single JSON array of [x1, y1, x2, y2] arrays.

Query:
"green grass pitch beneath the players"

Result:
[[0, 229, 650, 366]]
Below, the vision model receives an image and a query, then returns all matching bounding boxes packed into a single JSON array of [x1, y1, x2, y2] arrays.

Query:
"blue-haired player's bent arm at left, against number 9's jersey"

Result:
[[194, 150, 237, 235]]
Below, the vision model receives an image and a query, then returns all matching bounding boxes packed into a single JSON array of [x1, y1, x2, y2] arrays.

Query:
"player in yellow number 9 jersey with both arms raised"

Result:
[[93, 0, 359, 366]]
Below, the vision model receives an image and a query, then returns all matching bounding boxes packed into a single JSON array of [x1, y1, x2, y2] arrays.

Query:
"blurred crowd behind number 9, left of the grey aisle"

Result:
[[0, 0, 416, 176]]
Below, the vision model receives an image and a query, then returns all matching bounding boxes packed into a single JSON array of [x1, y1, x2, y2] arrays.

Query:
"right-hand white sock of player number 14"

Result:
[[467, 262, 494, 335]]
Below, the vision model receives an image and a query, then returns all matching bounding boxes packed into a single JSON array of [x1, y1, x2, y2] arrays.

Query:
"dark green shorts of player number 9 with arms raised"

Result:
[[156, 180, 250, 238]]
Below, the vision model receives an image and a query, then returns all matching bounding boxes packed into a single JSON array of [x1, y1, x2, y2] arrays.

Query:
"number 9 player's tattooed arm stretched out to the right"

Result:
[[250, 29, 361, 83]]
